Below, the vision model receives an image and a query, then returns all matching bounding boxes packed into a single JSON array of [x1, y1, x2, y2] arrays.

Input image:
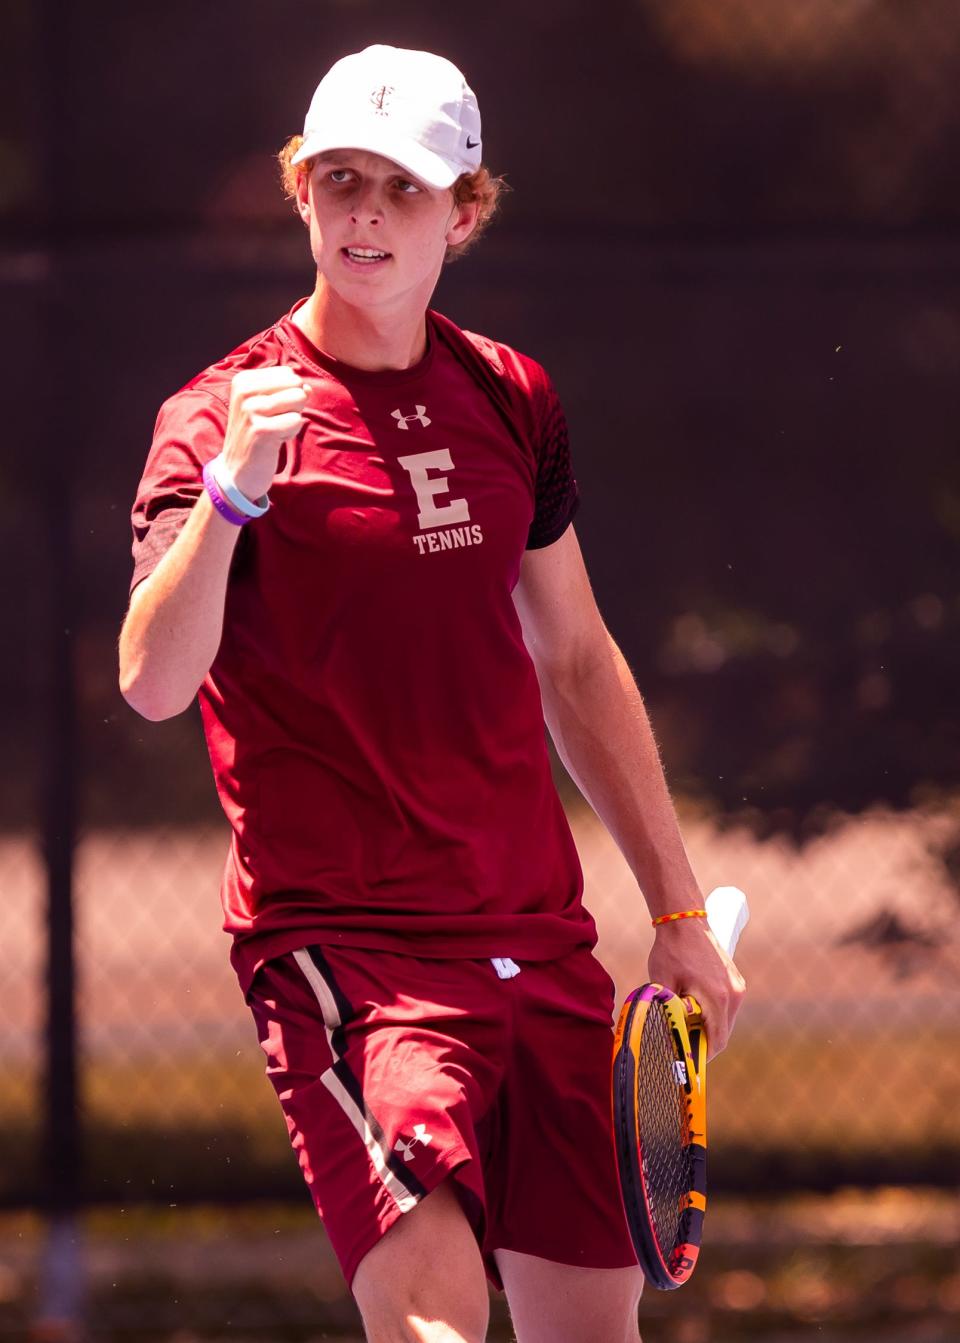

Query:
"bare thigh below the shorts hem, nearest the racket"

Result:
[[495, 1250, 643, 1343]]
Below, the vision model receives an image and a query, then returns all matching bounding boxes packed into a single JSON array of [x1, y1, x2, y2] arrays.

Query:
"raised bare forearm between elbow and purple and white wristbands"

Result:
[[119, 494, 239, 720]]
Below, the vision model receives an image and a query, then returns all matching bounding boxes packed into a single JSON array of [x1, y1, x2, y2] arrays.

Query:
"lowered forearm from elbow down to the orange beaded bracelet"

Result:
[[540, 635, 701, 917]]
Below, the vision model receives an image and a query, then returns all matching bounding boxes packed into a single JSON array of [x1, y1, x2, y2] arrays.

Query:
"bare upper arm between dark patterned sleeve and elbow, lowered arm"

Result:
[[513, 525, 607, 677]]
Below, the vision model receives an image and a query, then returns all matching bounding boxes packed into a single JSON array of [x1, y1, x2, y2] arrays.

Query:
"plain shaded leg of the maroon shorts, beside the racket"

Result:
[[487, 951, 636, 1269]]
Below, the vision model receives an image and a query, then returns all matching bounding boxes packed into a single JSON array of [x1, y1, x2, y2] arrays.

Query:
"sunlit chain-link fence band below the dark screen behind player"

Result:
[[0, 807, 960, 1203]]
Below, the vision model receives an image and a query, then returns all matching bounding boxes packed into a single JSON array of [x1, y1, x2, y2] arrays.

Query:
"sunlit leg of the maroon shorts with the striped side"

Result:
[[250, 947, 510, 1285]]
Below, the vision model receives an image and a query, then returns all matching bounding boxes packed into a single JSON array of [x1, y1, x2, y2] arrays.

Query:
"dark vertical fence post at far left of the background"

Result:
[[35, 0, 83, 1326]]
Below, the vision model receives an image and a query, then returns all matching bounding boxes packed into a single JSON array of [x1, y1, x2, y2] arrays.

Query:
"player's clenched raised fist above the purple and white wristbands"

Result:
[[223, 364, 309, 500]]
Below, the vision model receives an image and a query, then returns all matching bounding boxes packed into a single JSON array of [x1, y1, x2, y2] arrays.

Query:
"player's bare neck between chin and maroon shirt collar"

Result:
[[293, 275, 427, 372]]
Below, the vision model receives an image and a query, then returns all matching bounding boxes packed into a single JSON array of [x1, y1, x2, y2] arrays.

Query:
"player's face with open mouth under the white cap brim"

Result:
[[297, 149, 479, 309]]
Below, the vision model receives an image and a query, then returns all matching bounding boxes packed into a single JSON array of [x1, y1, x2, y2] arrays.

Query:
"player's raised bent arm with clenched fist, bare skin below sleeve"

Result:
[[119, 365, 307, 719]]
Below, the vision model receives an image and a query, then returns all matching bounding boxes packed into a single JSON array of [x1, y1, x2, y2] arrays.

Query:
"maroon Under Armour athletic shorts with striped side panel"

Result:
[[248, 945, 636, 1287]]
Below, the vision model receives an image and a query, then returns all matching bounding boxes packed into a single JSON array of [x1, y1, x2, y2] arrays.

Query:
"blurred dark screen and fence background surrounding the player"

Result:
[[0, 0, 960, 1343]]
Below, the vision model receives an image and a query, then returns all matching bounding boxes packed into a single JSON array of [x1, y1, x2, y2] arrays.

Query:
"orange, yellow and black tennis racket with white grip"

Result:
[[614, 886, 749, 1291]]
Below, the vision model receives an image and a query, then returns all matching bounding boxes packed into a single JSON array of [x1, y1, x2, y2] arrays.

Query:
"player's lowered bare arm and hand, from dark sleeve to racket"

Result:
[[514, 526, 744, 1052]]
